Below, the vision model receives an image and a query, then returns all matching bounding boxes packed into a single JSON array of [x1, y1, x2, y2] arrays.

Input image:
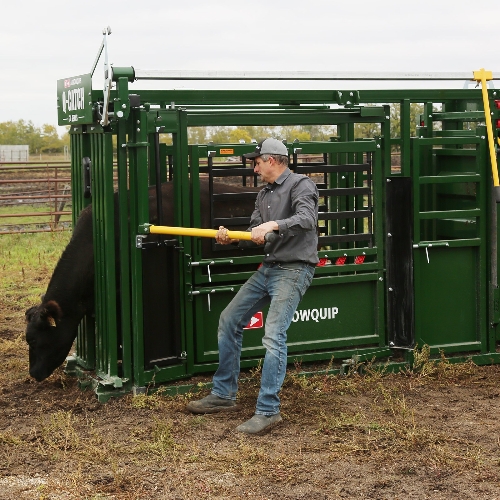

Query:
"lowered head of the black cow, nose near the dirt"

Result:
[[26, 300, 76, 382]]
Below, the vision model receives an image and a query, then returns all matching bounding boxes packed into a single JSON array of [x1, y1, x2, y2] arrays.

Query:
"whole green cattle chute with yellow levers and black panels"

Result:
[[62, 33, 500, 400]]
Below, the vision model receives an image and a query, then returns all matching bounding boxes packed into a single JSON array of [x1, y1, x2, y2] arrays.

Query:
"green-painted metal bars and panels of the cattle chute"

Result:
[[61, 64, 500, 401]]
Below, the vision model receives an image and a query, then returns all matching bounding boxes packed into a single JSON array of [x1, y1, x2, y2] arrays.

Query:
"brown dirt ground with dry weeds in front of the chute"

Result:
[[0, 280, 500, 500]]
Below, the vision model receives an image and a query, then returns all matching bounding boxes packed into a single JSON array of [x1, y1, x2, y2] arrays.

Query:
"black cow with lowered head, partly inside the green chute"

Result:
[[26, 180, 258, 382]]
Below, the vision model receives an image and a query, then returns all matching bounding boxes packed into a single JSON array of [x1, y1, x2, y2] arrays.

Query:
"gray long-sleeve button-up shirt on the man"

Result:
[[250, 168, 319, 265]]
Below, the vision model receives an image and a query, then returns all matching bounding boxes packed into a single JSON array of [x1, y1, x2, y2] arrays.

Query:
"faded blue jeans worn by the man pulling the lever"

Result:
[[212, 262, 314, 415]]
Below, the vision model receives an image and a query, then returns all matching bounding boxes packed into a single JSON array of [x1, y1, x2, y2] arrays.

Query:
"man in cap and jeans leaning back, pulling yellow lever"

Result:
[[187, 138, 318, 434]]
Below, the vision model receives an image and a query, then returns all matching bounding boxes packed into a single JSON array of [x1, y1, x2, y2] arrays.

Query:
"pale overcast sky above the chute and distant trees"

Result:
[[0, 0, 500, 135]]
